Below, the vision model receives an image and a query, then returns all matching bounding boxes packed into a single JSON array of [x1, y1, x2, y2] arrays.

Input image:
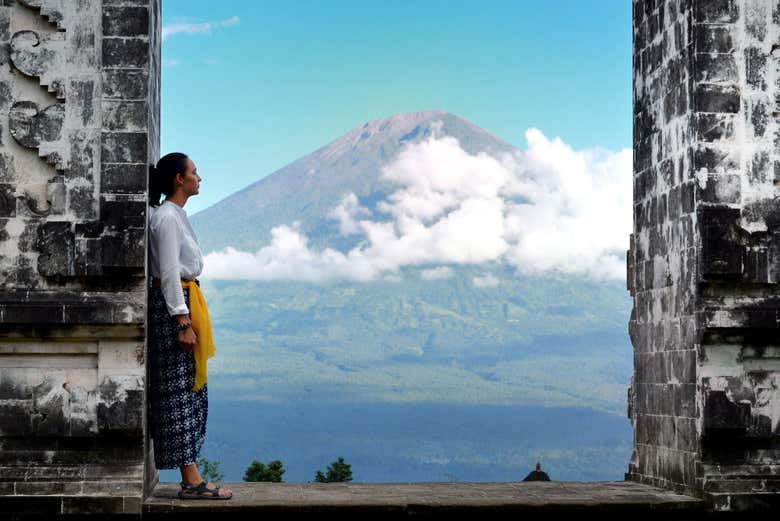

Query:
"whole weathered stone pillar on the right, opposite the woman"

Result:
[[626, 0, 780, 510]]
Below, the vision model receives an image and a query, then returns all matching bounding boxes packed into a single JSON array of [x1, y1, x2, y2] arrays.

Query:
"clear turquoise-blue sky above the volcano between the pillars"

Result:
[[161, 0, 632, 215]]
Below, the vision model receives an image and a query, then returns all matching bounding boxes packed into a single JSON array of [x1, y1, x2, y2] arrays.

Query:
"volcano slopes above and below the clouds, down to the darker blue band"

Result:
[[191, 111, 633, 417]]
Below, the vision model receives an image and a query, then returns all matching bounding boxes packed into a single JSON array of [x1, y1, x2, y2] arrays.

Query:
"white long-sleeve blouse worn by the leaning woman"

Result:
[[149, 199, 203, 315]]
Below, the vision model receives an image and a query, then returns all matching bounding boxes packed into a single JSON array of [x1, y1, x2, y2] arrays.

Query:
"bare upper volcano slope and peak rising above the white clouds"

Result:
[[190, 110, 516, 254]]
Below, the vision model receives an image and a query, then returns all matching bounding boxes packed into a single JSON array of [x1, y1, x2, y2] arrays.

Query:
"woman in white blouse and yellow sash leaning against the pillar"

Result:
[[148, 152, 233, 499]]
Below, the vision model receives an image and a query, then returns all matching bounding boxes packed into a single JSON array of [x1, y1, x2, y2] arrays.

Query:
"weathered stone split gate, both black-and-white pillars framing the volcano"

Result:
[[0, 0, 780, 517]]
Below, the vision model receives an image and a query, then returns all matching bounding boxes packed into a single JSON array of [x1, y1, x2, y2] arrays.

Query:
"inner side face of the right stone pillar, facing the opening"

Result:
[[626, 0, 697, 494]]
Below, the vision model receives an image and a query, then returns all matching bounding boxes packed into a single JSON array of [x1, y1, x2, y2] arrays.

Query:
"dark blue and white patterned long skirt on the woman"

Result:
[[147, 280, 208, 469]]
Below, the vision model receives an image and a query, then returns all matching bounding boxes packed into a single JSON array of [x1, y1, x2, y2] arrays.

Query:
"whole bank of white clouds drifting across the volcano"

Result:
[[203, 128, 632, 280]]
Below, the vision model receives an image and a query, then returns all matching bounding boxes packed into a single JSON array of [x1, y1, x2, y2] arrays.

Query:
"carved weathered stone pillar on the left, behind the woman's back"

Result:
[[0, 0, 160, 513]]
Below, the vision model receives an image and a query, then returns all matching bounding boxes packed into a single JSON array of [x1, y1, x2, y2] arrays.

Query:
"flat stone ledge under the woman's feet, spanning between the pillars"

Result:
[[137, 481, 706, 521]]
